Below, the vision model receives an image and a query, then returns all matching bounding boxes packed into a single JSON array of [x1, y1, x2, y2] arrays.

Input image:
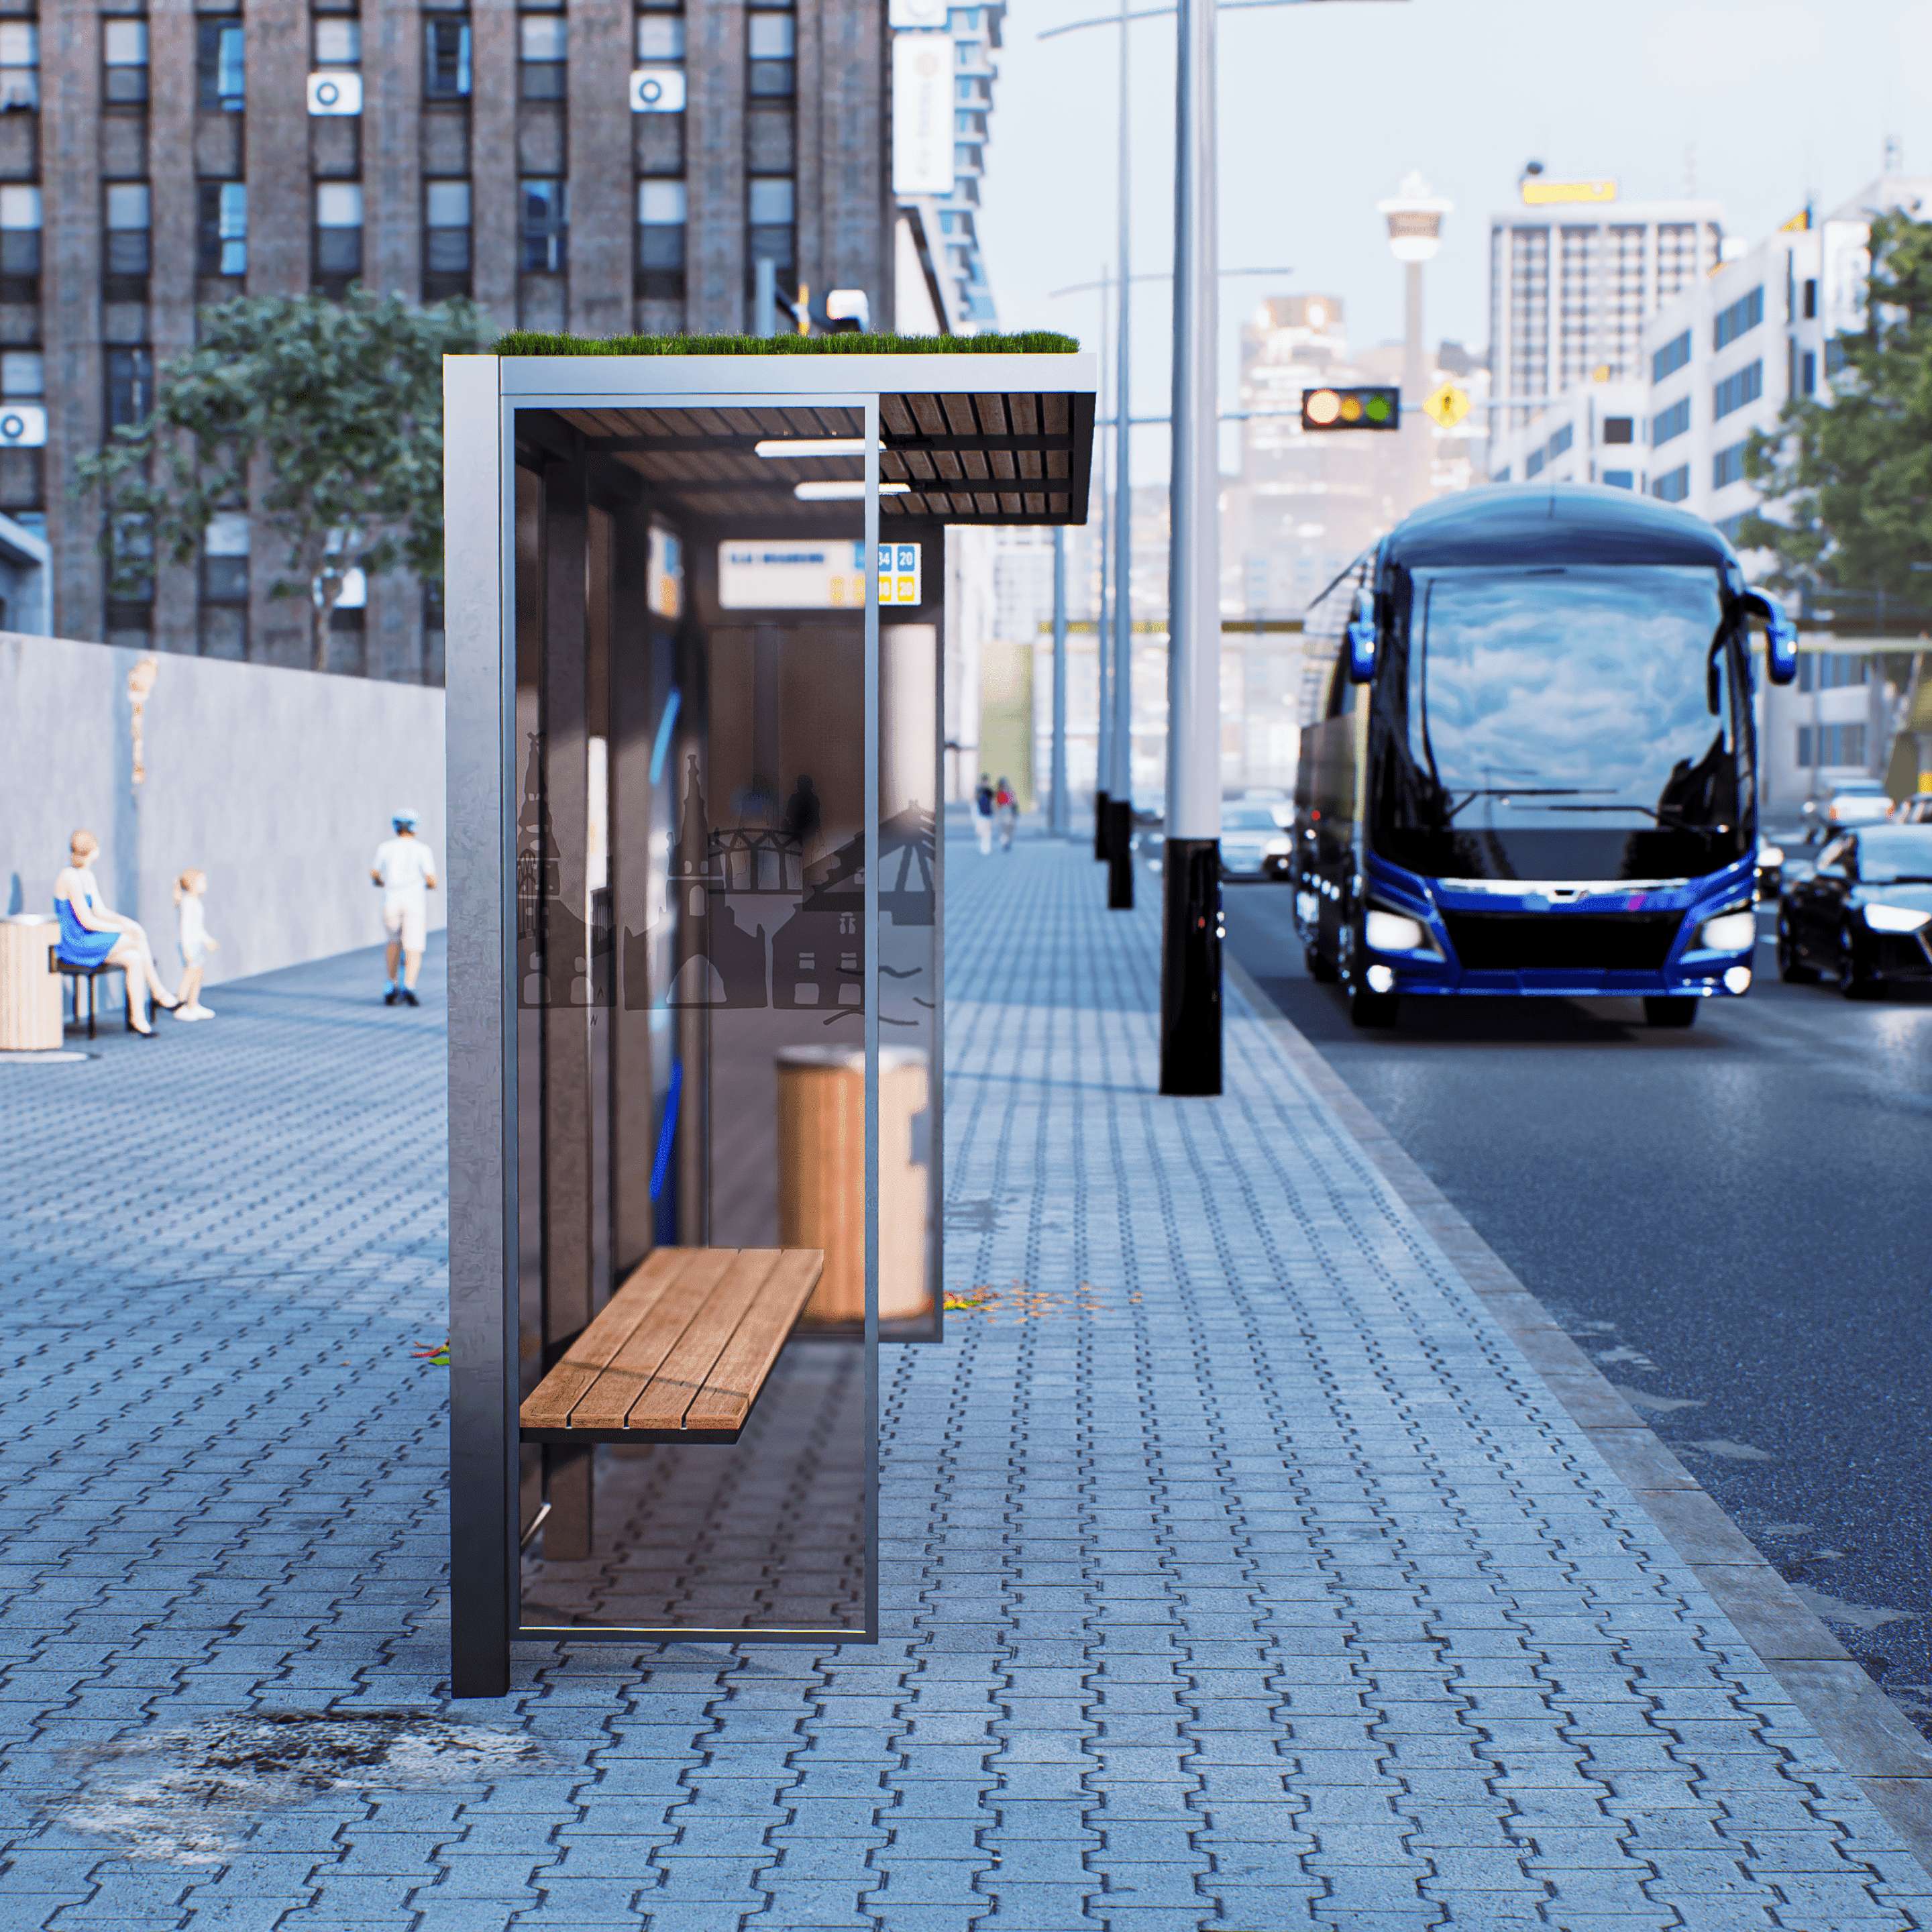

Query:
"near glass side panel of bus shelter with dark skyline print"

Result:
[[514, 404, 881, 1636]]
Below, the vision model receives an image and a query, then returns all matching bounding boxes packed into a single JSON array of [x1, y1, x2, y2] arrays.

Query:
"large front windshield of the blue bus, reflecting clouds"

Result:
[[1391, 566, 1747, 877]]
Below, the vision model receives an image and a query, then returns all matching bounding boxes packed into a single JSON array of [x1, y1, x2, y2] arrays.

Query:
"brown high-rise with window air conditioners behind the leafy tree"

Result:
[[15, 0, 894, 680]]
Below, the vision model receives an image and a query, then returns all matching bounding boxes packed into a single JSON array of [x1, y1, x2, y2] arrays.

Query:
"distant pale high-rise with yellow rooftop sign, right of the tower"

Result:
[[1489, 172, 1723, 433]]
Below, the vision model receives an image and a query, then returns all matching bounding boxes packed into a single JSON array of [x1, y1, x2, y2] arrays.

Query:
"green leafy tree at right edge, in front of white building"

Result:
[[1741, 213, 1932, 603]]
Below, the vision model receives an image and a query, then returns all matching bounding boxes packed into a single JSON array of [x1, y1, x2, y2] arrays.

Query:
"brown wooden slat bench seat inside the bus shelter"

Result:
[[520, 1248, 825, 1443]]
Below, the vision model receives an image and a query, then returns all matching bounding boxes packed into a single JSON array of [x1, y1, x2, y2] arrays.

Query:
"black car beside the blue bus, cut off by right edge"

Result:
[[1778, 825, 1932, 999]]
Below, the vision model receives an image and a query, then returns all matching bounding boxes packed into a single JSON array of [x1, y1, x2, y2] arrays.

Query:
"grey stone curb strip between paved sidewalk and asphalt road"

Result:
[[1223, 957, 1932, 1872]]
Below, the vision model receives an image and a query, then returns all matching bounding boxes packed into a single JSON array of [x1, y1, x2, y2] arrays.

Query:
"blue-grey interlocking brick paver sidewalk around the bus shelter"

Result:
[[0, 843, 1932, 1932]]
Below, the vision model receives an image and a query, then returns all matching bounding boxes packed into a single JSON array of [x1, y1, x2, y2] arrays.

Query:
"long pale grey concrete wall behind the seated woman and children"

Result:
[[0, 632, 444, 987]]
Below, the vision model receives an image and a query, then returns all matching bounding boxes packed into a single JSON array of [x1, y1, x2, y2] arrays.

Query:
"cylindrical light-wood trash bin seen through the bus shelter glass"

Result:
[[779, 1047, 933, 1322]]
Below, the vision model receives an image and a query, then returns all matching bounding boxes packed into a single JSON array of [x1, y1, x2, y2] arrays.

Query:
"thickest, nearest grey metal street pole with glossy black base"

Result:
[[1161, 0, 1223, 1093]]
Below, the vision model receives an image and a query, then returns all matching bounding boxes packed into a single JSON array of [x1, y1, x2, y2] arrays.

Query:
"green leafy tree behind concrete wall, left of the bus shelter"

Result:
[[75, 288, 494, 668]]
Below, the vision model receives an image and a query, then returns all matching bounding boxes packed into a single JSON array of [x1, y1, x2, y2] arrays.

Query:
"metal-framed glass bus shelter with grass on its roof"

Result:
[[444, 338, 1093, 1697]]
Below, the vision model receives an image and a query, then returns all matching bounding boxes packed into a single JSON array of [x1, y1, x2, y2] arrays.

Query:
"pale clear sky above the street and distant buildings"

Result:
[[979, 0, 1932, 481]]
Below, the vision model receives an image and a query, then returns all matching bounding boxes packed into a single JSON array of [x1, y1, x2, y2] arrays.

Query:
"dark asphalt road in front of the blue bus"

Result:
[[1227, 885, 1932, 1735]]
